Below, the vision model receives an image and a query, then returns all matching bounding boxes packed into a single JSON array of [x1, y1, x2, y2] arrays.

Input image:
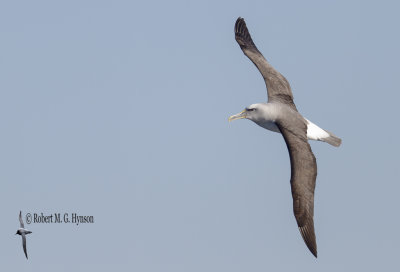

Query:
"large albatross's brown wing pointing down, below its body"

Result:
[[277, 122, 317, 257]]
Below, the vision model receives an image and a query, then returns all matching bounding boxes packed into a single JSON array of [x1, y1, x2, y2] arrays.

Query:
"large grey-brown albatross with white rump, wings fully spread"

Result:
[[229, 17, 342, 257]]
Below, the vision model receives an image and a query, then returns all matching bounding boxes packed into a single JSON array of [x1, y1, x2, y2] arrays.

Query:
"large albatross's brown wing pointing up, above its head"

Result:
[[235, 17, 297, 110]]
